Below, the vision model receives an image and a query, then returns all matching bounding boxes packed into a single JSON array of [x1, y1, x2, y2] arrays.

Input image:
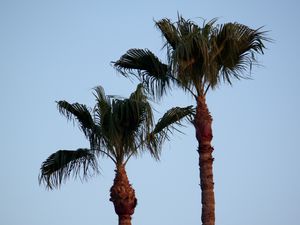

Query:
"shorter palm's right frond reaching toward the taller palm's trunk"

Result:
[[146, 106, 195, 159]]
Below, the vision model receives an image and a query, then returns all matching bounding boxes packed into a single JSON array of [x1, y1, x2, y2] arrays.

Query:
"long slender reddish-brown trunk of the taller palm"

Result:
[[194, 96, 215, 225]]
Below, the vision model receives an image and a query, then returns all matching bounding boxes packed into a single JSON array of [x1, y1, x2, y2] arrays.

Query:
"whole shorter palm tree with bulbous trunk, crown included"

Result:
[[39, 85, 194, 225]]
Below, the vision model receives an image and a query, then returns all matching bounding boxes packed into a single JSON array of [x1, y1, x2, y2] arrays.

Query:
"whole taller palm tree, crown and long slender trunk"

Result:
[[113, 16, 269, 225]]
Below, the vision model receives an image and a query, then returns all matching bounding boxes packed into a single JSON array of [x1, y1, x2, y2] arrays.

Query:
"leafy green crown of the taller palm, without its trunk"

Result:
[[114, 16, 269, 97]]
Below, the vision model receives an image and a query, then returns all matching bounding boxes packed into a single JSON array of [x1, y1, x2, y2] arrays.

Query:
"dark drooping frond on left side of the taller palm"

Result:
[[113, 49, 174, 98]]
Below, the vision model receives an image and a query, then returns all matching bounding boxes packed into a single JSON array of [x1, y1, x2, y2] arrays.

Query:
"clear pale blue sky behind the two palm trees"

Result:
[[0, 0, 300, 225]]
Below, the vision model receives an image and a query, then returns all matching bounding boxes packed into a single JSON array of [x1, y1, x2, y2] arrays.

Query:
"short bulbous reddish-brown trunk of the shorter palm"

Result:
[[110, 165, 137, 225]]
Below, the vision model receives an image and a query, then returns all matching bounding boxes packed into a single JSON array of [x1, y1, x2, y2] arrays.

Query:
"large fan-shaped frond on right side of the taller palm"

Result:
[[212, 23, 270, 84]]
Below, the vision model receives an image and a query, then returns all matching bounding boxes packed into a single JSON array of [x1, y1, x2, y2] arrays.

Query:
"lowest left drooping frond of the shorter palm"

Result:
[[39, 149, 99, 189]]
